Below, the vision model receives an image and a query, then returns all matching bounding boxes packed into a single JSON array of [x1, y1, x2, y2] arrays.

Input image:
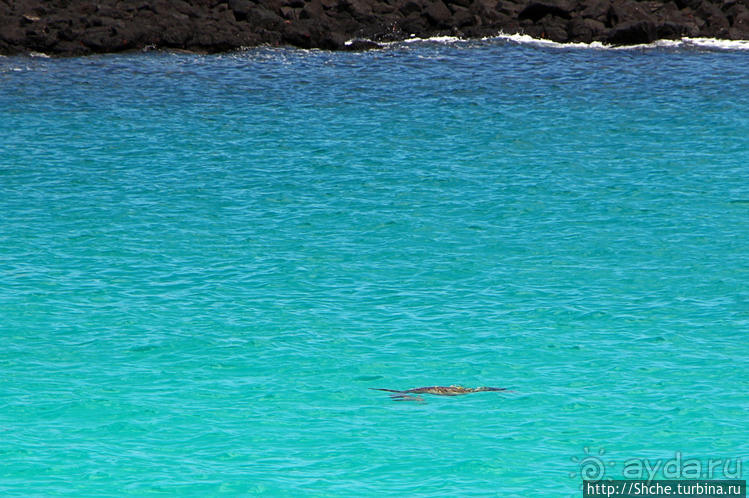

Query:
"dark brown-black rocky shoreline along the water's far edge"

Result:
[[0, 0, 749, 56]]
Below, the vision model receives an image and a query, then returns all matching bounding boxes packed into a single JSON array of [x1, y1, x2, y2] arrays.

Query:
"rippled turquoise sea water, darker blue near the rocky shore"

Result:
[[0, 38, 749, 497]]
